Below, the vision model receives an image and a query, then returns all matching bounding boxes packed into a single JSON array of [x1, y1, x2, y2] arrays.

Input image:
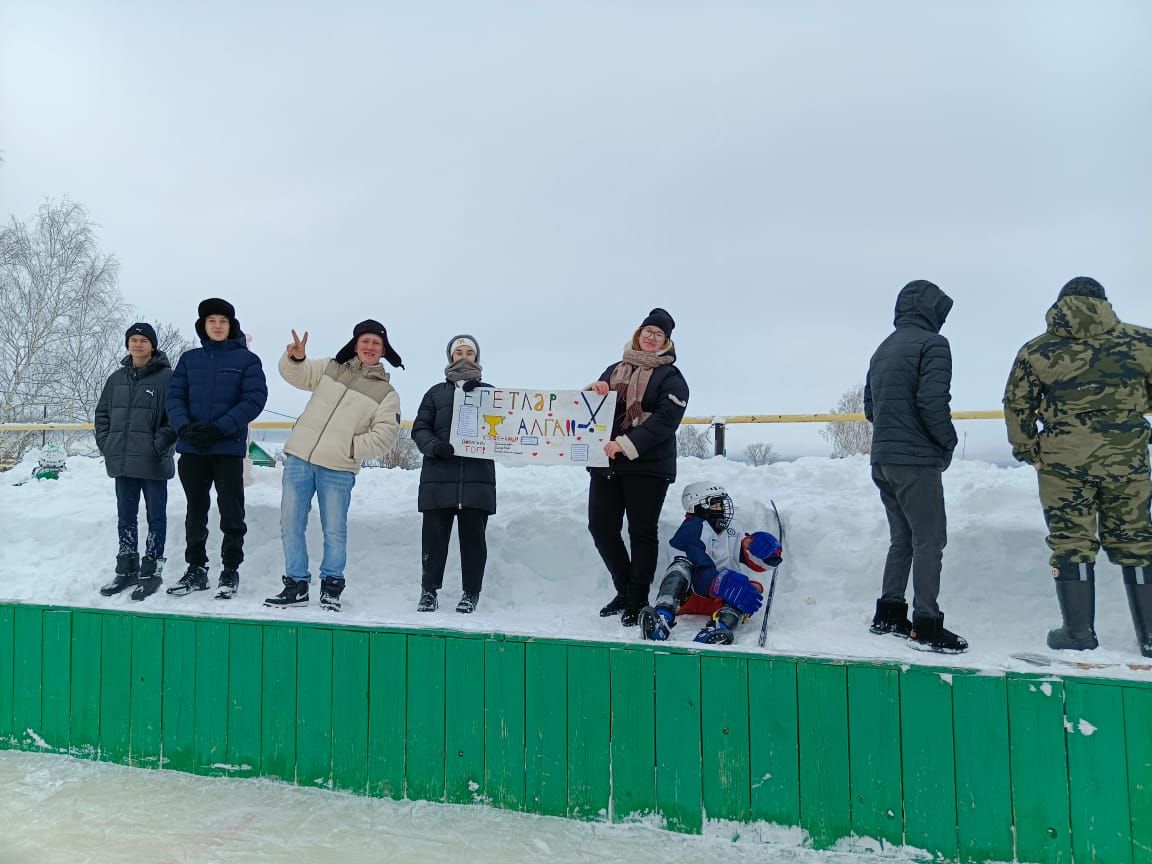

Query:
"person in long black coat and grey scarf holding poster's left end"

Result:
[[412, 334, 497, 613]]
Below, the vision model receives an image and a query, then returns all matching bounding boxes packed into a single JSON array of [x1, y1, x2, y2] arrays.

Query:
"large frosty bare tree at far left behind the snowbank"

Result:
[[0, 199, 127, 458]]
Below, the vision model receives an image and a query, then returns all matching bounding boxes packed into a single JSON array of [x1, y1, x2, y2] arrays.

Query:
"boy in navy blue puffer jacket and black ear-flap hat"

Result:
[[166, 297, 268, 600]]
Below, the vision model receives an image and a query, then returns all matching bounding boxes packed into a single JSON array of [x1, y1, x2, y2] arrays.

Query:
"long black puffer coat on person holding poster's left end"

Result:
[[412, 381, 497, 515]]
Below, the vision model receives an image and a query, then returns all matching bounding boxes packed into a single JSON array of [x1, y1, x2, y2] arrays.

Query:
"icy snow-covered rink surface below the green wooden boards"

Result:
[[0, 752, 926, 864]]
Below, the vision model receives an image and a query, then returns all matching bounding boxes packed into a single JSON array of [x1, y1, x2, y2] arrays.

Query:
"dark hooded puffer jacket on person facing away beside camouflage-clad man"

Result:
[[864, 280, 956, 469]]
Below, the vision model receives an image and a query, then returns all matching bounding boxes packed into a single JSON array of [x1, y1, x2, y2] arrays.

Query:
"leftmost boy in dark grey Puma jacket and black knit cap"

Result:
[[94, 321, 176, 600]]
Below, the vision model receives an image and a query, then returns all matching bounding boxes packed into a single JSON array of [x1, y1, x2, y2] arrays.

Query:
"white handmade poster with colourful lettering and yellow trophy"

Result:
[[450, 387, 616, 468]]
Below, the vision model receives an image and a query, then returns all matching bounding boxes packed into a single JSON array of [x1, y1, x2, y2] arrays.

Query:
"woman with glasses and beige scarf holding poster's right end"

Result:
[[585, 308, 688, 627]]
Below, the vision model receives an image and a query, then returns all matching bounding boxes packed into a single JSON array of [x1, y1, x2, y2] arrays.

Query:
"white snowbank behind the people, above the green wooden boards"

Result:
[[0, 454, 1142, 674]]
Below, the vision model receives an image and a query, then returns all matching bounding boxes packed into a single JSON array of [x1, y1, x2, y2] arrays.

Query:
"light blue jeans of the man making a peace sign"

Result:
[[280, 456, 356, 582]]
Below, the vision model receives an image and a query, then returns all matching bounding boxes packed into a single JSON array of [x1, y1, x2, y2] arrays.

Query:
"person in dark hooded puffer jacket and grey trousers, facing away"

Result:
[[864, 279, 968, 653]]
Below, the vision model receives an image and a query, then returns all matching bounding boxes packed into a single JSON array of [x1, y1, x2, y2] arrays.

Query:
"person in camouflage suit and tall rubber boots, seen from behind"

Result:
[[1003, 276, 1152, 657]]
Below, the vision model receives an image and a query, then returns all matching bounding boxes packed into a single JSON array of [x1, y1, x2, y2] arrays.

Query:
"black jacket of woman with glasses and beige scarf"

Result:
[[588, 348, 688, 480]]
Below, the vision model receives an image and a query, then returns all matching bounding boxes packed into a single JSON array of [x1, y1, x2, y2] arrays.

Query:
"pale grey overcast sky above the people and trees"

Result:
[[0, 0, 1152, 455]]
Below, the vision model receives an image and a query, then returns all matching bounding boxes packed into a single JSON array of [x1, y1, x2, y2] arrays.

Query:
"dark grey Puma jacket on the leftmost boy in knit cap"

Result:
[[96, 351, 176, 480]]
